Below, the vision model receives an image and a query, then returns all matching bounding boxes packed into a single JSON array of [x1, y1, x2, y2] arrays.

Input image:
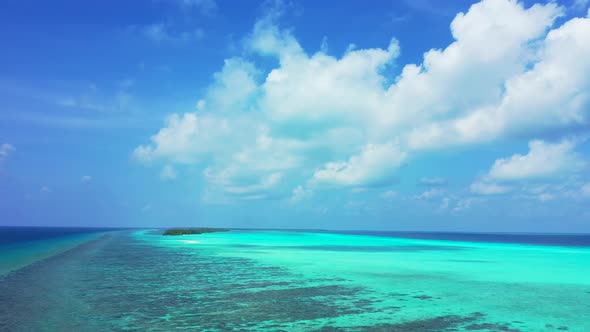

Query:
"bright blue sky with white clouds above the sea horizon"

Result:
[[0, 0, 590, 233]]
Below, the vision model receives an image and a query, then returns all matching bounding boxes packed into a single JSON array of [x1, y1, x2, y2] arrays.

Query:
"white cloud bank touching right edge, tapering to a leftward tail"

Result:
[[409, 8, 590, 148]]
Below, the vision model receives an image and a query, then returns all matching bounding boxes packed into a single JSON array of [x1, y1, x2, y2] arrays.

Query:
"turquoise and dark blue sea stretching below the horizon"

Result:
[[0, 228, 590, 332]]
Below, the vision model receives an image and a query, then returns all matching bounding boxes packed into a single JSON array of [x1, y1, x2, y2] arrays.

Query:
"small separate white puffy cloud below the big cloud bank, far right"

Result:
[[488, 140, 583, 180]]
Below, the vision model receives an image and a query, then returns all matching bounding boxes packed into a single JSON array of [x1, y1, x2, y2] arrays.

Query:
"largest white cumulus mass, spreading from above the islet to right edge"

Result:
[[134, 0, 590, 199]]
